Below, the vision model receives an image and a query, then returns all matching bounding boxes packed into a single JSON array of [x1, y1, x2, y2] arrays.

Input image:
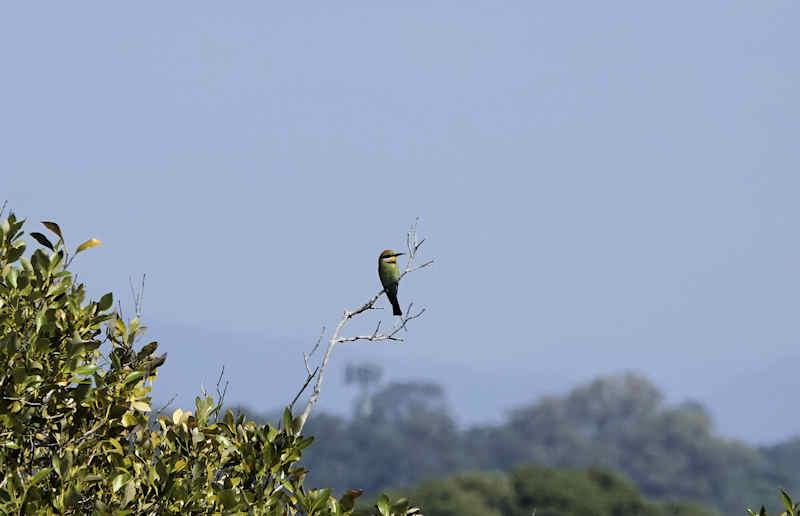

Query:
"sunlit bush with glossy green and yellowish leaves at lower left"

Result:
[[0, 214, 418, 516]]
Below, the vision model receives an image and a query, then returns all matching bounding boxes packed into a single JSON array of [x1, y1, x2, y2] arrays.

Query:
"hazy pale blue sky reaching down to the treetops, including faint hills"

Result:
[[0, 0, 800, 441]]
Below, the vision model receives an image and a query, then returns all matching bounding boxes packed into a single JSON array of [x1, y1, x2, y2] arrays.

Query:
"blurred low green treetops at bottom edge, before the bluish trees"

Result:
[[396, 466, 718, 516]]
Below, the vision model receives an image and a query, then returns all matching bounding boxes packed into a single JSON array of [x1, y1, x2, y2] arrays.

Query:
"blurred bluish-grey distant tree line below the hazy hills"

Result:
[[244, 373, 800, 514]]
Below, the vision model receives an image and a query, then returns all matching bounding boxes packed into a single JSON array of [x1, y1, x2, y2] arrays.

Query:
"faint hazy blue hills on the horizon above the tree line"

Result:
[[141, 321, 800, 444]]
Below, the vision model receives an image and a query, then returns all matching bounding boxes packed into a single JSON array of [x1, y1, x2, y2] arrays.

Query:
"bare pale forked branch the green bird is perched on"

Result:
[[289, 218, 433, 432]]
